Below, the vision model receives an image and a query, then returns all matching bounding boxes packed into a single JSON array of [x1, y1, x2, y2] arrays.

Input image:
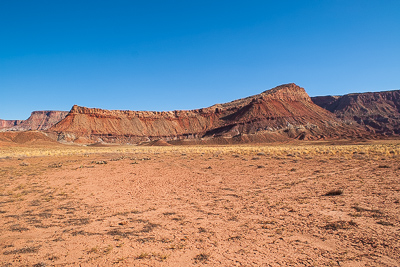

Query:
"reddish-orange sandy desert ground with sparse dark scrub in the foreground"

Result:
[[0, 144, 400, 266]]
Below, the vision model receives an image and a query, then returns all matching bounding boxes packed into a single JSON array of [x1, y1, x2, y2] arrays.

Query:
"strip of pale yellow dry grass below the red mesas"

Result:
[[0, 141, 400, 160]]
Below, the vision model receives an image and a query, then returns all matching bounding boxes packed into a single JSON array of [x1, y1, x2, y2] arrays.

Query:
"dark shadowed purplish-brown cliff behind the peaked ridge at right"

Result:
[[312, 90, 400, 136]]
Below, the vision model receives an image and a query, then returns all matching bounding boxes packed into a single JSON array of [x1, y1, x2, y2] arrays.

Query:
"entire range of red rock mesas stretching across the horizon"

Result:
[[0, 83, 400, 146]]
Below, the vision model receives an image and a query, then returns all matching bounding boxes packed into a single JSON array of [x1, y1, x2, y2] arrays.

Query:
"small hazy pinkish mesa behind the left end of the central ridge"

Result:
[[5, 110, 68, 131]]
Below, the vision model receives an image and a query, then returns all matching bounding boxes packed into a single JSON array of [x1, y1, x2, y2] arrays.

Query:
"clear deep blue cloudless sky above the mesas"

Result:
[[0, 0, 400, 119]]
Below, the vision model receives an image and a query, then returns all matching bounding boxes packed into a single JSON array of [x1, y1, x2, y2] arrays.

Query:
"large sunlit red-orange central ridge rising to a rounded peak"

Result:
[[49, 84, 366, 143]]
